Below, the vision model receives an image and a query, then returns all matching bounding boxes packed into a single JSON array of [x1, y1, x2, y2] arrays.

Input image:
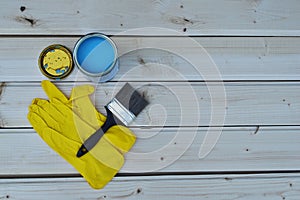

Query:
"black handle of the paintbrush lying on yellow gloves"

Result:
[[76, 107, 117, 158]]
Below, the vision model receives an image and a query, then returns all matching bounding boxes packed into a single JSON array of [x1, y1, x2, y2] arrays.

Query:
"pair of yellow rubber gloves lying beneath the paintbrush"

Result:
[[28, 82, 135, 189]]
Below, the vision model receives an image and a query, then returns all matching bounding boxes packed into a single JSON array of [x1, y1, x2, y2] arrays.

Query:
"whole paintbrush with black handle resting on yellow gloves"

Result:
[[76, 83, 149, 157]]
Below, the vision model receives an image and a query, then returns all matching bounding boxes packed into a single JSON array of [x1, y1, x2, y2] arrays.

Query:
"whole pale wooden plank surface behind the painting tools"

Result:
[[0, 0, 300, 200]]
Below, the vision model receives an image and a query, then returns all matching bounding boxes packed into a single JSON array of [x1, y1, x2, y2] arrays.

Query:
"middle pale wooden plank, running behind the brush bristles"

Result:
[[0, 82, 300, 127]]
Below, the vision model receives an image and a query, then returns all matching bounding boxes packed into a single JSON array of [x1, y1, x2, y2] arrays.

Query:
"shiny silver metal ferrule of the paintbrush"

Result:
[[106, 98, 136, 126]]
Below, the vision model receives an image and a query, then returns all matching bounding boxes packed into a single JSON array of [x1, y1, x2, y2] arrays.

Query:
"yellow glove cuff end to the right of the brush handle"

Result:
[[103, 125, 136, 153]]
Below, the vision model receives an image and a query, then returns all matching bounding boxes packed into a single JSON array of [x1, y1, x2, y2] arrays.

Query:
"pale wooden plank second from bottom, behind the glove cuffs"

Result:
[[0, 127, 300, 176]]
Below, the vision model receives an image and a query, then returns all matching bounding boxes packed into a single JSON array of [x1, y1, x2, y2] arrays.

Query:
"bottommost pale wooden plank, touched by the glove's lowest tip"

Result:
[[0, 173, 300, 200]]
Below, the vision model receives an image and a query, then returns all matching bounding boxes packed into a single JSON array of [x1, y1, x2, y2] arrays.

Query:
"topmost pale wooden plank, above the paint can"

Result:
[[0, 0, 300, 36]]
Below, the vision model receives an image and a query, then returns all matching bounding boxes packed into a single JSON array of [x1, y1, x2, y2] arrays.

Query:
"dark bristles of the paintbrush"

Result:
[[115, 83, 149, 116]]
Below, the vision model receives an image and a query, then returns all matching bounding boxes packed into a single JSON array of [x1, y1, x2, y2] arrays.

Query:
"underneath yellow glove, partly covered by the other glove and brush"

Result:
[[41, 80, 136, 153]]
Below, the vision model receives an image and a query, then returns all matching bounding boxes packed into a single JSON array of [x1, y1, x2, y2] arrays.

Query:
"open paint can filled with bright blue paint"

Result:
[[73, 33, 119, 82]]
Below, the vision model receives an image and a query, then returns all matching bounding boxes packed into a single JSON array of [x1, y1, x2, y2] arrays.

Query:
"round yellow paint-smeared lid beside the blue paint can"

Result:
[[38, 44, 73, 79]]
